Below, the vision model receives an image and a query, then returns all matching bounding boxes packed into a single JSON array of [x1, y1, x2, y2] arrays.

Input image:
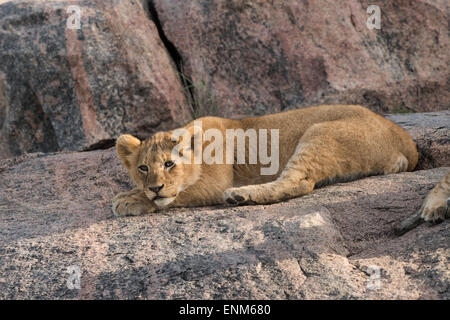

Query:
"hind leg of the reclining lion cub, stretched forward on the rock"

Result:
[[223, 119, 396, 204]]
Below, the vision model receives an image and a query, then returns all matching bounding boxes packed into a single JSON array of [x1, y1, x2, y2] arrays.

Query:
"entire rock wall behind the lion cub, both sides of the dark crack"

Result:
[[0, 0, 450, 158]]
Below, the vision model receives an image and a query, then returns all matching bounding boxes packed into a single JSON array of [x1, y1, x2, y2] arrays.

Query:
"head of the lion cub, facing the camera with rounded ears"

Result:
[[116, 127, 201, 207]]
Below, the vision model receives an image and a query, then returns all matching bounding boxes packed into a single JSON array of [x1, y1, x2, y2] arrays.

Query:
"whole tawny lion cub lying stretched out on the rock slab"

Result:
[[113, 105, 418, 216]]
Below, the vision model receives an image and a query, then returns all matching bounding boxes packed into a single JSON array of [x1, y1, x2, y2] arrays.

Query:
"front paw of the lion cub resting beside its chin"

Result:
[[112, 190, 156, 216]]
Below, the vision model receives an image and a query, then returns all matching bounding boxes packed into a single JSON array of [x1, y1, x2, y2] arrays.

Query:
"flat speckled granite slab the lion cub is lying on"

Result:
[[0, 111, 450, 299]]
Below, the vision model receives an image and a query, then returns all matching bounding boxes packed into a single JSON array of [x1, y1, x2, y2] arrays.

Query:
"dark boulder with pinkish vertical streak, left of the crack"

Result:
[[0, 0, 191, 158]]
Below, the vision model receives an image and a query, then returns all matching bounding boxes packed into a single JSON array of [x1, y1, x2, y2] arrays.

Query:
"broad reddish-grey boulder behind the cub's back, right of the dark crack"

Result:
[[150, 0, 450, 116]]
